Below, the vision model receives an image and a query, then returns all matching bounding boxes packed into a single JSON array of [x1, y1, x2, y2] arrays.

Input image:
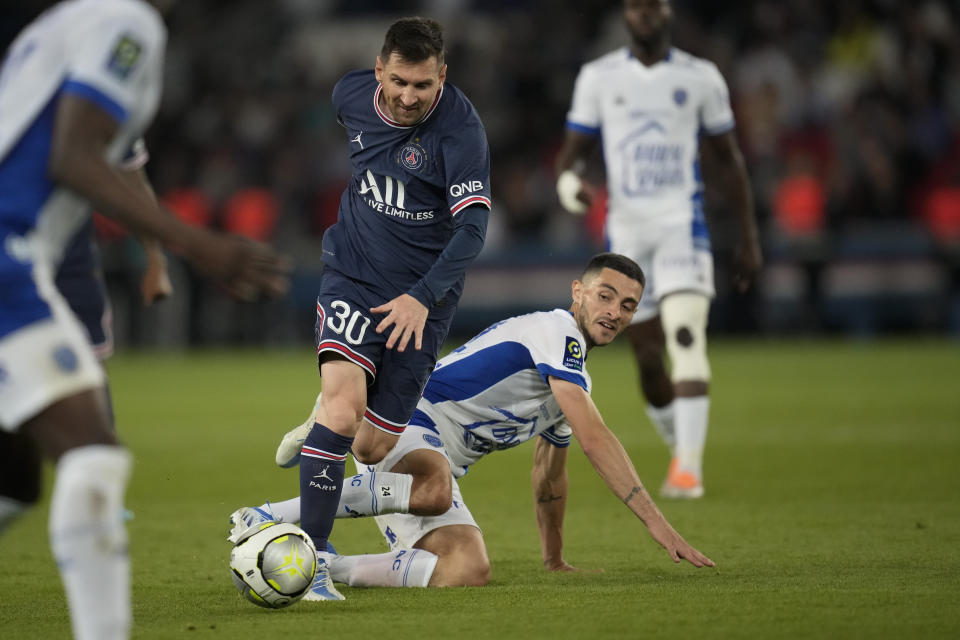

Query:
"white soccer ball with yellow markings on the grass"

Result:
[[230, 522, 317, 609]]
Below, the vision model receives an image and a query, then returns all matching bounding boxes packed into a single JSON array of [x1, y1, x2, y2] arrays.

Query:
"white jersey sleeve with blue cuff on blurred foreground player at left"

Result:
[[63, 5, 166, 122]]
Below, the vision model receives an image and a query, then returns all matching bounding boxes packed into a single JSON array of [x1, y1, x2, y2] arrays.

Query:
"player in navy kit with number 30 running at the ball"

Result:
[[288, 18, 490, 600]]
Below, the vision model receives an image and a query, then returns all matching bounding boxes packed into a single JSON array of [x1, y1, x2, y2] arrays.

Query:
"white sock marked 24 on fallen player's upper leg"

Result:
[[260, 471, 413, 522]]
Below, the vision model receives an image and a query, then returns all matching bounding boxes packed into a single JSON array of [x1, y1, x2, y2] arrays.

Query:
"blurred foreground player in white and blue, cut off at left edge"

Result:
[[0, 0, 287, 640]]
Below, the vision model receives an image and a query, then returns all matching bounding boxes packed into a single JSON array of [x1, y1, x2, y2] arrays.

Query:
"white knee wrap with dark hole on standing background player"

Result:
[[660, 292, 710, 383]]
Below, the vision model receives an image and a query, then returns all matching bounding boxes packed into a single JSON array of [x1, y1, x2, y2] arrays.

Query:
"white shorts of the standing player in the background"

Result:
[[608, 223, 716, 324]]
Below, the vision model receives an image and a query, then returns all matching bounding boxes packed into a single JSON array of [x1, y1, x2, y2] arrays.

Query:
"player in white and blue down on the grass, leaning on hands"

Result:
[[230, 253, 713, 587]]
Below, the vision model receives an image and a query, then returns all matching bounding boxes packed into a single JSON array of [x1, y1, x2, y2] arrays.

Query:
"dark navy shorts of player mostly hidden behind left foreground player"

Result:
[[56, 218, 113, 360]]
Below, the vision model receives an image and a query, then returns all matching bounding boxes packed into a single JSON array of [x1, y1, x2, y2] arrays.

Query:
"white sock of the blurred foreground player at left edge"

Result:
[[50, 445, 132, 640]]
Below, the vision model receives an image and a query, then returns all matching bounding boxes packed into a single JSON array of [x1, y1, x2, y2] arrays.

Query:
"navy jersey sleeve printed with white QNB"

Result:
[[443, 113, 491, 215]]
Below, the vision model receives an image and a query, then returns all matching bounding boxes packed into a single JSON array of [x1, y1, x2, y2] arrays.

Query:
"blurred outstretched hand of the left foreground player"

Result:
[[187, 232, 292, 302]]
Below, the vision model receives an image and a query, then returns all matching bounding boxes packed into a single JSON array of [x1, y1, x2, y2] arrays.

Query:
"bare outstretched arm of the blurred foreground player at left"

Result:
[[48, 93, 286, 299]]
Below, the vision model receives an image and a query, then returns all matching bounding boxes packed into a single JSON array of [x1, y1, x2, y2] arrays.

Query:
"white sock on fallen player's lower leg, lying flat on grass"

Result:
[[330, 549, 438, 587]]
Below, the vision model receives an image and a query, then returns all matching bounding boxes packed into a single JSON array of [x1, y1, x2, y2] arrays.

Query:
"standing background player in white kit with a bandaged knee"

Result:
[[556, 0, 762, 498]]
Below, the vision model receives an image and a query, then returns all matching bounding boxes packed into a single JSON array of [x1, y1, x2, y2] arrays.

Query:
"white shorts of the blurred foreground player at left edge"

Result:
[[0, 270, 106, 431]]
